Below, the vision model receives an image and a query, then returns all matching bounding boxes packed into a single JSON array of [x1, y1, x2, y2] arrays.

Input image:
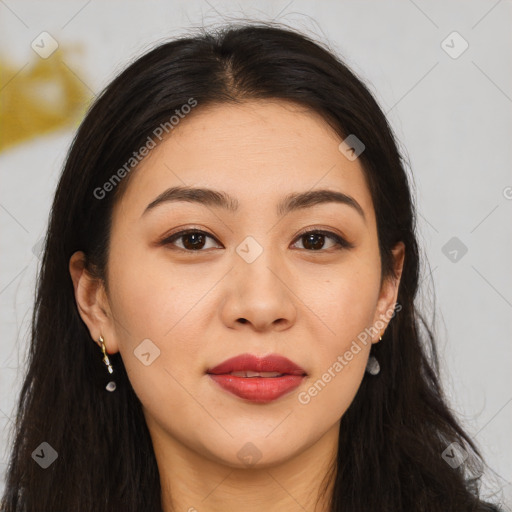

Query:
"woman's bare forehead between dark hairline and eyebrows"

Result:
[[114, 100, 374, 225]]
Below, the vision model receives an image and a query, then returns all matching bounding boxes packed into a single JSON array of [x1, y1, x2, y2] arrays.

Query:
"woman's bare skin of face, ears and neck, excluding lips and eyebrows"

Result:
[[69, 101, 404, 512]]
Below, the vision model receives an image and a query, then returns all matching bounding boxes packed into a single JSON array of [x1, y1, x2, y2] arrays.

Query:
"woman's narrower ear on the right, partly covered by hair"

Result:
[[372, 242, 405, 343]]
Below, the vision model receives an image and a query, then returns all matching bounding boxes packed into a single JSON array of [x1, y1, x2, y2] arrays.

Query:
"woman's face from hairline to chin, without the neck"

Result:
[[76, 101, 401, 467]]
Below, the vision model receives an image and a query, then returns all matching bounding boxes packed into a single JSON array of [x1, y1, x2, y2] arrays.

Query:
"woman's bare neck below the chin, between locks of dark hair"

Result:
[[152, 422, 339, 512]]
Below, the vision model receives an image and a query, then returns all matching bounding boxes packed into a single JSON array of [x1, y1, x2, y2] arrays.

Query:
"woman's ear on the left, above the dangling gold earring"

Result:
[[69, 251, 119, 354]]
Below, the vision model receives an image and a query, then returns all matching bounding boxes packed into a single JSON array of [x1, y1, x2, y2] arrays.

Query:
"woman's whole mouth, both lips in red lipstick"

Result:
[[207, 354, 307, 403]]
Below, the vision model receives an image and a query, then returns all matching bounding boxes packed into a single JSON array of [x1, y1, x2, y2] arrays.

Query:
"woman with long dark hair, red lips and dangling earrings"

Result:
[[2, 24, 495, 512]]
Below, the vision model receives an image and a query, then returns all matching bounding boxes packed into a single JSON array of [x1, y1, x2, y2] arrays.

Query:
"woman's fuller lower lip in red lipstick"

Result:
[[208, 373, 304, 403]]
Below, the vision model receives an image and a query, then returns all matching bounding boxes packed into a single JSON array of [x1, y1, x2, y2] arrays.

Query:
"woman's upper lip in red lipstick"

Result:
[[206, 354, 307, 375]]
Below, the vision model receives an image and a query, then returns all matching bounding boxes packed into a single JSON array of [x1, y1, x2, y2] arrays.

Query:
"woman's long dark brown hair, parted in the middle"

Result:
[[2, 23, 500, 512]]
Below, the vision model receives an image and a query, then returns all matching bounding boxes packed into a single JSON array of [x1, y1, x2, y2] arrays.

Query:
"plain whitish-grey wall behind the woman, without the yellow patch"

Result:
[[0, 0, 512, 503]]
